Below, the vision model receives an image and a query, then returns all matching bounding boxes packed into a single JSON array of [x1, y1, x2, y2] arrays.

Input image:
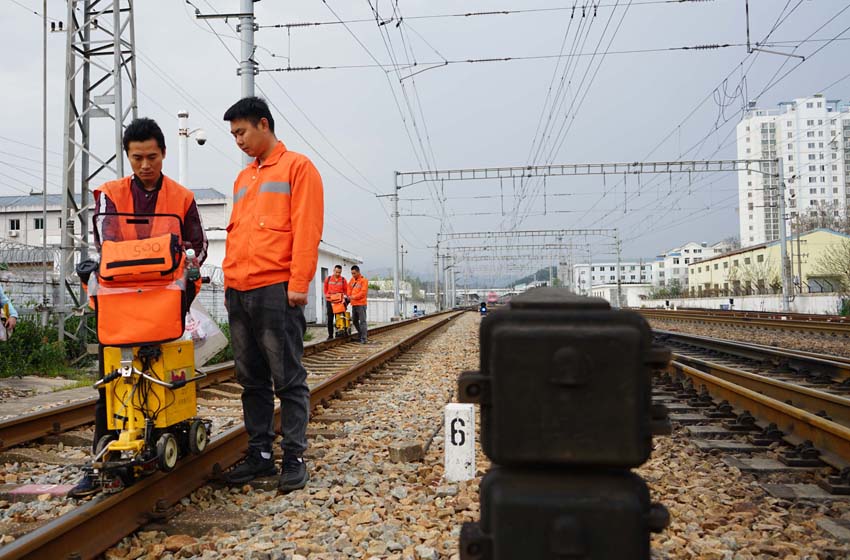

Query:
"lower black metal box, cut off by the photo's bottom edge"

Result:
[[460, 467, 669, 560]]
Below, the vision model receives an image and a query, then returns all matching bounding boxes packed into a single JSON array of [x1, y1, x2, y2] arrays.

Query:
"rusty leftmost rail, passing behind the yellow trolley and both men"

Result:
[[0, 312, 447, 451]]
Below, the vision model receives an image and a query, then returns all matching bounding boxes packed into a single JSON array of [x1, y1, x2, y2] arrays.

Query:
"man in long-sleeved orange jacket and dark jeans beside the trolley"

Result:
[[222, 97, 324, 492]]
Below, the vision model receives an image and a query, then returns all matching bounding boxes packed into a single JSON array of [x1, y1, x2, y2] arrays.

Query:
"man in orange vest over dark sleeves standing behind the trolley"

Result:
[[68, 118, 207, 498]]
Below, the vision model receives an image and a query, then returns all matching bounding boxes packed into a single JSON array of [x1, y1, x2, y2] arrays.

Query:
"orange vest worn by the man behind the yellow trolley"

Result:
[[94, 175, 195, 242]]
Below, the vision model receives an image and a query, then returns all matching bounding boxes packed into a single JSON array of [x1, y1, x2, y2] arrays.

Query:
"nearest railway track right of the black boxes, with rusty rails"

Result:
[[656, 331, 850, 493]]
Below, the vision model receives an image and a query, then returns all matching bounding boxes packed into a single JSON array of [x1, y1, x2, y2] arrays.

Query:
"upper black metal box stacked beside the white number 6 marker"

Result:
[[458, 288, 669, 468]]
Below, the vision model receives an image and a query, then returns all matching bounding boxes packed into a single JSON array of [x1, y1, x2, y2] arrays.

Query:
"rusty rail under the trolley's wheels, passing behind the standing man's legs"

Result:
[[0, 311, 463, 560]]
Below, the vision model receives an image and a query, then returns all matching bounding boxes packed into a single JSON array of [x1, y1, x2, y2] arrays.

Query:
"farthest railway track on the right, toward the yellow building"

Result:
[[638, 309, 850, 338]]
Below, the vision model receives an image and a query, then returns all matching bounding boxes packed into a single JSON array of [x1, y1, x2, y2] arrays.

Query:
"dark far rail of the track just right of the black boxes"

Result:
[[653, 329, 850, 383]]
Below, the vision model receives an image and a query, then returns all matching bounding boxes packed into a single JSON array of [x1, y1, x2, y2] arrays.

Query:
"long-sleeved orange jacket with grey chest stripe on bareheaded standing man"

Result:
[[222, 142, 324, 293]]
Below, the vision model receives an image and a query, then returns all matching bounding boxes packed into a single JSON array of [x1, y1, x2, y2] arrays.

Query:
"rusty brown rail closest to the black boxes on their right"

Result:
[[667, 361, 850, 469]]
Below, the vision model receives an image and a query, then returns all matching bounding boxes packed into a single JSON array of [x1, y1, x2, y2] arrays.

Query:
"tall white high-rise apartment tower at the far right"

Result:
[[737, 95, 850, 247]]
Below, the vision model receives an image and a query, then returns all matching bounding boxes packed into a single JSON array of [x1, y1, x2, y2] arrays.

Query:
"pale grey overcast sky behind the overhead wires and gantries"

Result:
[[0, 0, 850, 276]]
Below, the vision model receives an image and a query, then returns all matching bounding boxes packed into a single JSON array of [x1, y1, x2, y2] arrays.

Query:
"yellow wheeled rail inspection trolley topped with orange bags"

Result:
[[77, 214, 211, 491]]
